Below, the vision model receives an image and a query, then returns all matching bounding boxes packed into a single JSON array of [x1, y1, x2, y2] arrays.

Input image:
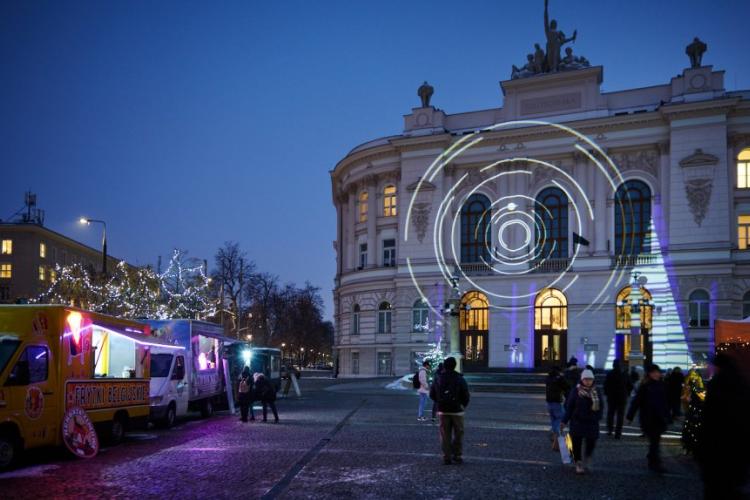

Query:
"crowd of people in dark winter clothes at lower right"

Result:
[[546, 353, 750, 498]]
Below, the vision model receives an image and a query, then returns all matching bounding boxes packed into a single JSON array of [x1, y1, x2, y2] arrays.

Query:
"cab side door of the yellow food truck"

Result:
[[5, 343, 60, 448]]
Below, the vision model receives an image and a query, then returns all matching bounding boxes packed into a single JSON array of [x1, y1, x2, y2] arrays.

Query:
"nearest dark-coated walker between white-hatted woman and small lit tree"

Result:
[[628, 364, 669, 474]]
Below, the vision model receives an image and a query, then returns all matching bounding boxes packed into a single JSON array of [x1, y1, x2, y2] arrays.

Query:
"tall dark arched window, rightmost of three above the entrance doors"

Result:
[[615, 180, 651, 255]]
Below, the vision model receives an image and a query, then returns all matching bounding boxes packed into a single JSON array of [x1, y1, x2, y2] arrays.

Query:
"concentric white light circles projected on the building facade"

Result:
[[404, 120, 624, 313]]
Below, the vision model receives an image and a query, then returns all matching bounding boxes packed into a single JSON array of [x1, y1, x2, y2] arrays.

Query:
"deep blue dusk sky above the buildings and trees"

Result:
[[0, 0, 750, 317]]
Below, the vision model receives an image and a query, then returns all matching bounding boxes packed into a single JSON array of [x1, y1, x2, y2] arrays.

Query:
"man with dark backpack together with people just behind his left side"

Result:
[[415, 357, 470, 465]]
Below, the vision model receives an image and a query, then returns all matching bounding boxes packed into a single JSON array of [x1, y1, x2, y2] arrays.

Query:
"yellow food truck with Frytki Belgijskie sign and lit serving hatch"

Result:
[[0, 305, 181, 468]]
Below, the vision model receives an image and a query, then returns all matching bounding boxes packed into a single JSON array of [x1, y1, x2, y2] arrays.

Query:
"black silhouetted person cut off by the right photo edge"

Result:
[[695, 353, 750, 499]]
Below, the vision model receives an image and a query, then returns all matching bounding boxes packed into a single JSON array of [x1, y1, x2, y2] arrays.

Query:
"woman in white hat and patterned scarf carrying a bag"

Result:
[[561, 370, 602, 474]]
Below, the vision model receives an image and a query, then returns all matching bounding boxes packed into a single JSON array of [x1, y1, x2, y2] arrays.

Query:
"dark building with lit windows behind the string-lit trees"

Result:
[[0, 222, 120, 304]]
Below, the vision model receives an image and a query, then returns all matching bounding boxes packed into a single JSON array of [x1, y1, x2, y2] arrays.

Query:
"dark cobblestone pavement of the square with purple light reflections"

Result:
[[0, 378, 700, 500]]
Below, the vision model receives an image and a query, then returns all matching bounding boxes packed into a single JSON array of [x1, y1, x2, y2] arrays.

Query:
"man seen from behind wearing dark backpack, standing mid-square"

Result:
[[430, 357, 469, 465]]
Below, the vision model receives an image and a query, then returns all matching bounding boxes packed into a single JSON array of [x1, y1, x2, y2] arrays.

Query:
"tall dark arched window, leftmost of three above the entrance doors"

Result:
[[461, 194, 492, 263]]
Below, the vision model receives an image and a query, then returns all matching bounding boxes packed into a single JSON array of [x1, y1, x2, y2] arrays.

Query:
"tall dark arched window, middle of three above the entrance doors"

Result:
[[535, 187, 568, 259]]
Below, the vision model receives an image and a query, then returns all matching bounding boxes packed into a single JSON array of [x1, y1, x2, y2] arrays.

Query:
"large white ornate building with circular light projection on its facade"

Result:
[[331, 42, 750, 376]]
